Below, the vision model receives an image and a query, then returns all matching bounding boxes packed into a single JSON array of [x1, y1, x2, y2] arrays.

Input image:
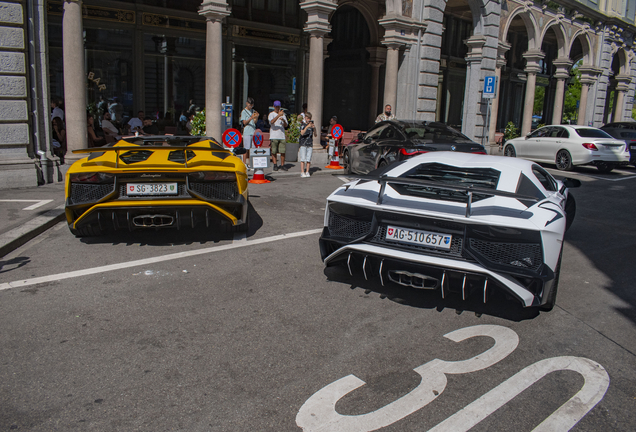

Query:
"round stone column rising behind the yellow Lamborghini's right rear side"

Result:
[[199, 0, 230, 142]]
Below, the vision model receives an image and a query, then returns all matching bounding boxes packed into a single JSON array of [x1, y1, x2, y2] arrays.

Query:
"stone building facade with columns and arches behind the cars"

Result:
[[0, 0, 636, 187]]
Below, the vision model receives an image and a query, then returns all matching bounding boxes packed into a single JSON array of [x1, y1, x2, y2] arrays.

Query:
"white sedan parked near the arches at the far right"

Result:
[[504, 125, 629, 172]]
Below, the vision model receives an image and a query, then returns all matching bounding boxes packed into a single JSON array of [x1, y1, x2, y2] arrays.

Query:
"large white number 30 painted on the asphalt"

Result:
[[296, 325, 609, 432]]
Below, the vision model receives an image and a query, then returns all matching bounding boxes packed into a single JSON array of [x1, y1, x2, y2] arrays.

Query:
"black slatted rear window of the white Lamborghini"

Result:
[[400, 163, 501, 189]]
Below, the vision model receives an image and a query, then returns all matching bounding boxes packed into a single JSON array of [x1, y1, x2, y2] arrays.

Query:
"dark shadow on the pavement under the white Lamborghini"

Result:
[[324, 266, 539, 321]]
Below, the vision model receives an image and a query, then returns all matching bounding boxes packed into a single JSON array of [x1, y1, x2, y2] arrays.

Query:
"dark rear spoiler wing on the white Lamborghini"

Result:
[[346, 175, 545, 217]]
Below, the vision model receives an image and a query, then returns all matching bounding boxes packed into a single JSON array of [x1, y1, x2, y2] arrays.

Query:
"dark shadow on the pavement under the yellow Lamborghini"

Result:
[[81, 203, 263, 246]]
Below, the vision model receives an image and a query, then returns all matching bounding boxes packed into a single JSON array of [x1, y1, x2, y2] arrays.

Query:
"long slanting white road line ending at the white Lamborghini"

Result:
[[0, 228, 322, 291]]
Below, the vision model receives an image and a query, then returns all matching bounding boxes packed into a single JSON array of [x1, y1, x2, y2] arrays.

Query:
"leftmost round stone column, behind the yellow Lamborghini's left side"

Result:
[[62, 0, 88, 159]]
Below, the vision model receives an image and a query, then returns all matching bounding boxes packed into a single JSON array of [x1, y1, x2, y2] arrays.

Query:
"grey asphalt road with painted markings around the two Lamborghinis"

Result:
[[0, 164, 636, 432]]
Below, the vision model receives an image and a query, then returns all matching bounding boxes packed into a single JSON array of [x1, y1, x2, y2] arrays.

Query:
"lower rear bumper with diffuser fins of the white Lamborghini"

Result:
[[320, 235, 554, 307]]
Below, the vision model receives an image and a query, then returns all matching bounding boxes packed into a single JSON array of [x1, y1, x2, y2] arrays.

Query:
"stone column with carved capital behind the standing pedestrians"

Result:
[[300, 0, 337, 149]]
